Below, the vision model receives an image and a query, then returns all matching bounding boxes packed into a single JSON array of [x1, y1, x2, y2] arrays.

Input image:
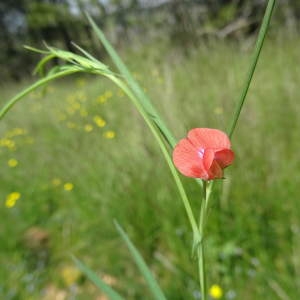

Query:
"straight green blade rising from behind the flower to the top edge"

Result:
[[228, 0, 276, 137]]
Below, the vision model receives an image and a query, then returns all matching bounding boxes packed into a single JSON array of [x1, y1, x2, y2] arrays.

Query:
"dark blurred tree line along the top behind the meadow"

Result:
[[0, 0, 300, 80]]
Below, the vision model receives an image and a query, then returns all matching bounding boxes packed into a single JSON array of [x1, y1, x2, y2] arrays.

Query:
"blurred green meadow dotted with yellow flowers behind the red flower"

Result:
[[0, 36, 300, 300]]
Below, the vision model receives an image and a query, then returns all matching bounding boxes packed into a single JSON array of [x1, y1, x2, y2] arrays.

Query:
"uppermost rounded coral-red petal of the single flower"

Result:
[[188, 128, 231, 149]]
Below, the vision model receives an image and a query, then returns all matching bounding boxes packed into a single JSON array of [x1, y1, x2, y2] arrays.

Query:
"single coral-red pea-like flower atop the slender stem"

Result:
[[173, 128, 234, 180]]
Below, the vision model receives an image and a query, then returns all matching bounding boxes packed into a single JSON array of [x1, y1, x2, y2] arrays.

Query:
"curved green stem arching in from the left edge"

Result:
[[0, 67, 80, 120]]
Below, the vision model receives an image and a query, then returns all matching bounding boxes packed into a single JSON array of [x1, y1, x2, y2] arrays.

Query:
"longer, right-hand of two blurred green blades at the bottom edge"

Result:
[[115, 221, 166, 300]]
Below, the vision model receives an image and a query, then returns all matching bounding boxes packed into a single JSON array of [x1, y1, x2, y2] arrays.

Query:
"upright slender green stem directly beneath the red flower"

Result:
[[198, 180, 208, 300]]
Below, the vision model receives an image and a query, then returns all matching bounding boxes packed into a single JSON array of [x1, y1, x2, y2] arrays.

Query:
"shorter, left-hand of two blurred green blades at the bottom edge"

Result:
[[72, 256, 125, 300]]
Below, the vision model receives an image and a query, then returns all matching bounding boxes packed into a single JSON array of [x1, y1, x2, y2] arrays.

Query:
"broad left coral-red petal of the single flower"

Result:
[[173, 139, 208, 179]]
